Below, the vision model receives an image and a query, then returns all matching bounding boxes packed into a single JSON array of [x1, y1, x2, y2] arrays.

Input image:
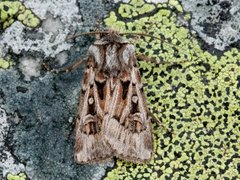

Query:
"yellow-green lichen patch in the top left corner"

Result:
[[0, 1, 41, 29]]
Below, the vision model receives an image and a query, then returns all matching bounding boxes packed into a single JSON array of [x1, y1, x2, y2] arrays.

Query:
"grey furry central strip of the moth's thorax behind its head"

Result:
[[104, 44, 121, 76]]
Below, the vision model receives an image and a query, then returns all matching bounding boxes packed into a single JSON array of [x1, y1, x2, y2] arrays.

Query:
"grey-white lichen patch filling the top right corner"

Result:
[[182, 0, 240, 50]]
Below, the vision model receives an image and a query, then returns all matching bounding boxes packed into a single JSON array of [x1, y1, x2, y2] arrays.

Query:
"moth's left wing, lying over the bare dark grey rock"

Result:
[[74, 60, 113, 164]]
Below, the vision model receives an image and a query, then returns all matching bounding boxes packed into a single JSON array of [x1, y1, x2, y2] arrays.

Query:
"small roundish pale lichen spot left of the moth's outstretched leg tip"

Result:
[[19, 56, 42, 81]]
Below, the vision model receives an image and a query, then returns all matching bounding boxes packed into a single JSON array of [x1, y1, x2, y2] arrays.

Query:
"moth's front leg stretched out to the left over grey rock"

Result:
[[43, 58, 87, 74]]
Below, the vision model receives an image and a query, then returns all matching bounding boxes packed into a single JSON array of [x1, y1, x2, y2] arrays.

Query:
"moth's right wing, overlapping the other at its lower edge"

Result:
[[103, 67, 153, 163]]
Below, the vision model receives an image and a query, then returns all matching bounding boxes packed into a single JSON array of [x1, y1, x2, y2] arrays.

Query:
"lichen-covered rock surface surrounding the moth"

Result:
[[0, 0, 240, 180]]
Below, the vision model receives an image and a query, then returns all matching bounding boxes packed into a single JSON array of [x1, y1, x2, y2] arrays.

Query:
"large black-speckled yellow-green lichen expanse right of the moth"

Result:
[[105, 0, 240, 179]]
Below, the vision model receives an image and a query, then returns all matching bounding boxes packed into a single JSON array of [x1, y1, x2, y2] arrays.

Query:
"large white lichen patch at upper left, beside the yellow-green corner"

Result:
[[0, 0, 82, 57]]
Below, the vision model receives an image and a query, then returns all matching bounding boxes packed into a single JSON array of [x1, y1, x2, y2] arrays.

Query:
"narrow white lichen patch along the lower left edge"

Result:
[[0, 108, 25, 177]]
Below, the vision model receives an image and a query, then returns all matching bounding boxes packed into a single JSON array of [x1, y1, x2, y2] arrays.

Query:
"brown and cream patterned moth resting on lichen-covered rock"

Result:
[[48, 30, 156, 164]]
